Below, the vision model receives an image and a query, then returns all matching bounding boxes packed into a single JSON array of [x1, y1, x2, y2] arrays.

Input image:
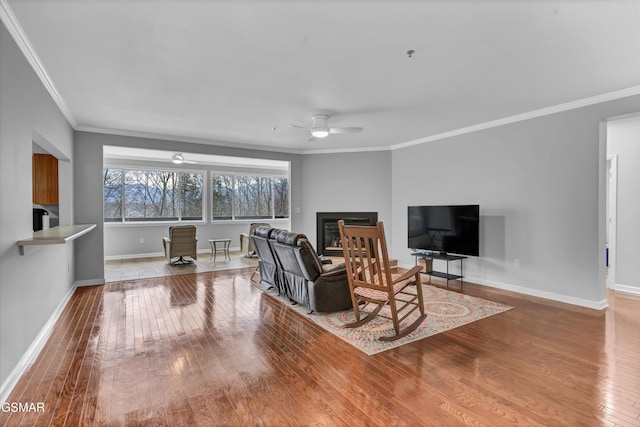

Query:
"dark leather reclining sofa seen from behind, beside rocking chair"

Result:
[[251, 227, 351, 313]]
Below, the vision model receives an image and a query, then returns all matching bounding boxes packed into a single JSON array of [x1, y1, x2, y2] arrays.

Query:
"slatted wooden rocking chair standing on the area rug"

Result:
[[338, 220, 427, 341]]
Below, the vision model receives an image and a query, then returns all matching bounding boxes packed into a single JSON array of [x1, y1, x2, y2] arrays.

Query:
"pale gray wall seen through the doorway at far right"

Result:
[[607, 117, 640, 293]]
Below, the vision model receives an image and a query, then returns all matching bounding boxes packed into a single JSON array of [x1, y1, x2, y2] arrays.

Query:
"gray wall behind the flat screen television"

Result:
[[391, 96, 640, 307]]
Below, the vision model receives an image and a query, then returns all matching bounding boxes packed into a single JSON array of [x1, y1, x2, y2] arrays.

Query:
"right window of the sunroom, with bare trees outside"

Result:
[[211, 174, 289, 221]]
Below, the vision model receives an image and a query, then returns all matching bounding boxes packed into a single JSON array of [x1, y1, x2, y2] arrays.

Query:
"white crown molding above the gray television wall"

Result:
[[391, 86, 640, 150]]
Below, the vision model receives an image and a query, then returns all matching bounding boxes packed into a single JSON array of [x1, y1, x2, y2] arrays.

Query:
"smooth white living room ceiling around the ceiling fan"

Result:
[[0, 0, 640, 152]]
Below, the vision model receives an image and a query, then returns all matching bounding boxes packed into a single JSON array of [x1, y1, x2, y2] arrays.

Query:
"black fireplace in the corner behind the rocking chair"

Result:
[[316, 212, 378, 256]]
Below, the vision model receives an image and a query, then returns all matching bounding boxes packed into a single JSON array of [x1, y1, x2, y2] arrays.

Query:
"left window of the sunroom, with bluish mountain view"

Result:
[[103, 169, 204, 222]]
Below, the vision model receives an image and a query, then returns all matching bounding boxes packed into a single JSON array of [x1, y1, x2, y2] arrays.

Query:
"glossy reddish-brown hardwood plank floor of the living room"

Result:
[[0, 268, 640, 426]]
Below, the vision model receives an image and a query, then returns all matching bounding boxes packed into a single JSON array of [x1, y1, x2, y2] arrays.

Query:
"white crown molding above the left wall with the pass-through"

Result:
[[0, 0, 78, 129]]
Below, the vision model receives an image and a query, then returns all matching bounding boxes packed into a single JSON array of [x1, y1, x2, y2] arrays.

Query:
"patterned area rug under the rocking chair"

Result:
[[263, 284, 513, 355]]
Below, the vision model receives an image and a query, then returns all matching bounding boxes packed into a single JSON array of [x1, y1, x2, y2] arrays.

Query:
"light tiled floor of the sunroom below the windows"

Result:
[[104, 251, 258, 282]]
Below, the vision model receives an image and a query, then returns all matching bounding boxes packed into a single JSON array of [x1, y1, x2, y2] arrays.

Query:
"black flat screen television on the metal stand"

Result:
[[408, 205, 480, 256]]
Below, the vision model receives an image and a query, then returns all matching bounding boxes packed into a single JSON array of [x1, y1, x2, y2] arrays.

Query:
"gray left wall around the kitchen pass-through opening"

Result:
[[0, 24, 75, 386]]
